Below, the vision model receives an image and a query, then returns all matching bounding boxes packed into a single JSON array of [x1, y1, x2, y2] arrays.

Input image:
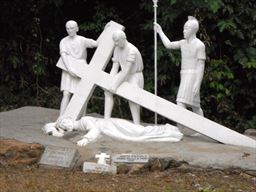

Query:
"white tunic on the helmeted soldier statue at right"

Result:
[[171, 38, 206, 107]]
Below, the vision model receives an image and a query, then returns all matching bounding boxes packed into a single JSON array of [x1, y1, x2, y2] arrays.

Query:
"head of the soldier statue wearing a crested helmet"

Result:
[[183, 16, 199, 39]]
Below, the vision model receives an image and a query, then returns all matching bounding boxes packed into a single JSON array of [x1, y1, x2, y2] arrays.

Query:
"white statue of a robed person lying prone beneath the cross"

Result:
[[43, 116, 183, 146]]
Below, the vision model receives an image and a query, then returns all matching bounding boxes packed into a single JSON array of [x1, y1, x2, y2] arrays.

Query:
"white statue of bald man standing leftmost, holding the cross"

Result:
[[57, 20, 97, 116]]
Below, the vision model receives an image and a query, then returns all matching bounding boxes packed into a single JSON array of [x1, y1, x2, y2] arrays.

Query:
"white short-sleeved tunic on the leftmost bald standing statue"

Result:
[[60, 35, 97, 93]]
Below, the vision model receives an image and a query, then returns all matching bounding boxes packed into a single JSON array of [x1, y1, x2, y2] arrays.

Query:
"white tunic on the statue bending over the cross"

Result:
[[112, 42, 144, 88]]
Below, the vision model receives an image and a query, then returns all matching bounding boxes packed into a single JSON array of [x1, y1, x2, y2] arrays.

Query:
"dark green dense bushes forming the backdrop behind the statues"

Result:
[[0, 0, 256, 131]]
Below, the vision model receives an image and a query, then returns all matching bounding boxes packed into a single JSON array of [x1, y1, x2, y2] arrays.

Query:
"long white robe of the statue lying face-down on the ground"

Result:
[[78, 116, 183, 143]]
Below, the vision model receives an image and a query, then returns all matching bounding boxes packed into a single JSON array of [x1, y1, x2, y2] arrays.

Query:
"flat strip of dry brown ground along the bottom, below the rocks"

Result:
[[0, 166, 256, 192]]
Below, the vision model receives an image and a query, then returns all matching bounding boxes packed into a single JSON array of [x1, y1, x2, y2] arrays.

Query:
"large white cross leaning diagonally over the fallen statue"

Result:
[[59, 23, 256, 148]]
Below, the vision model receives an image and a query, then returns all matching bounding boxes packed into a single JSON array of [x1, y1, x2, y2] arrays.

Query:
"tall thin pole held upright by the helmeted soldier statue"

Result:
[[153, 0, 158, 125]]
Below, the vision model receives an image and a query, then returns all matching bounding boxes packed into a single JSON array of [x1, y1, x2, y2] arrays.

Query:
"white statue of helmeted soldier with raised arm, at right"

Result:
[[154, 16, 206, 116]]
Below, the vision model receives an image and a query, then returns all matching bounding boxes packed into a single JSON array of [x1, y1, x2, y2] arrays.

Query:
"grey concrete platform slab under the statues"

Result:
[[0, 106, 256, 170]]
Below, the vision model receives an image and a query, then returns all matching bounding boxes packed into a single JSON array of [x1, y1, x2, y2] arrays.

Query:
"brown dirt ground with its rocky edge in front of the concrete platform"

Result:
[[0, 139, 256, 192]]
